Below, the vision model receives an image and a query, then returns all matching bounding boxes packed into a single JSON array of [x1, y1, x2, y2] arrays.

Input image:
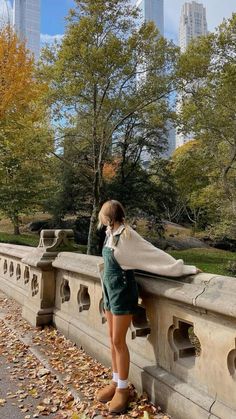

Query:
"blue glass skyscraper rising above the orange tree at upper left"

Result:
[[13, 0, 40, 60]]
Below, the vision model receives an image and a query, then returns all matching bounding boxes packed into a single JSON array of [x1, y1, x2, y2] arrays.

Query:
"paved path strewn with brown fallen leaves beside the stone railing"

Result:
[[0, 292, 169, 419]]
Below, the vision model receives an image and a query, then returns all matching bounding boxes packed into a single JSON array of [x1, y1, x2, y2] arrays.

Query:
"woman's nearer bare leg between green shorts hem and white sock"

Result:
[[110, 314, 132, 380]]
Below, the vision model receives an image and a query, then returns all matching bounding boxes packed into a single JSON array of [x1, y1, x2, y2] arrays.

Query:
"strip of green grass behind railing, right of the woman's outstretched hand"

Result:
[[168, 249, 236, 276]]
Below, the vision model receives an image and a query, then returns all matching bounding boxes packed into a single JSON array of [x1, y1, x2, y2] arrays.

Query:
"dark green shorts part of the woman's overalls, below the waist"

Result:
[[103, 270, 138, 315]]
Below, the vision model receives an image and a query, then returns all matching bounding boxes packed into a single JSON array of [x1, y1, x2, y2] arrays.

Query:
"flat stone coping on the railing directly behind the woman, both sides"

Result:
[[52, 252, 236, 318]]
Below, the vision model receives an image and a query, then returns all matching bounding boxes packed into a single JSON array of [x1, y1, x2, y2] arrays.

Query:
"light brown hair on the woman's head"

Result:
[[98, 199, 131, 240]]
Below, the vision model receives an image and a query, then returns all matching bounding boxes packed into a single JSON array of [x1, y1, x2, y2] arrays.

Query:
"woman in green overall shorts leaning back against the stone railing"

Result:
[[96, 200, 200, 414]]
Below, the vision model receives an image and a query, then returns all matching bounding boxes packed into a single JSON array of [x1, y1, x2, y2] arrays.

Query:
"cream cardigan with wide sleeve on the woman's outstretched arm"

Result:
[[98, 225, 197, 277]]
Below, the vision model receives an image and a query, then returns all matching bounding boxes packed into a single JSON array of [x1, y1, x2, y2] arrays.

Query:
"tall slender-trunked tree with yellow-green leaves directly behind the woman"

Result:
[[41, 0, 177, 253]]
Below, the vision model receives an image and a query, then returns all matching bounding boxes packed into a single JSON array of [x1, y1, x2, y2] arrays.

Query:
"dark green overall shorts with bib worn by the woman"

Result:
[[102, 232, 138, 315]]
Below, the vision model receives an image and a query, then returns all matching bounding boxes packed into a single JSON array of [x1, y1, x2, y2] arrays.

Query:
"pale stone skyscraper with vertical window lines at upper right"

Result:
[[176, 1, 208, 147]]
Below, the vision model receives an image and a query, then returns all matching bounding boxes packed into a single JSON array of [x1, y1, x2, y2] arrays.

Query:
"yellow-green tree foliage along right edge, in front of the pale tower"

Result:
[[175, 15, 236, 238]]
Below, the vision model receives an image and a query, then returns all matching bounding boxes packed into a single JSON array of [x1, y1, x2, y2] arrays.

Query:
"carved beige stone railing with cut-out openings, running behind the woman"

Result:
[[0, 230, 236, 419]]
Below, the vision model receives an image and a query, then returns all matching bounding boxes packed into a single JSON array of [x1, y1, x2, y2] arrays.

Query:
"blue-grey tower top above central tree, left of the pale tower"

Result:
[[136, 0, 164, 35]]
